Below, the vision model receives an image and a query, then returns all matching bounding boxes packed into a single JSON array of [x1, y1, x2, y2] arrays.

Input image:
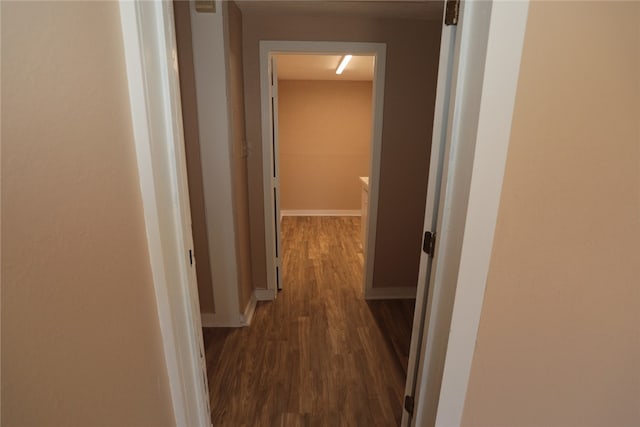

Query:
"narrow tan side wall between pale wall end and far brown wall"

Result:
[[223, 1, 253, 312]]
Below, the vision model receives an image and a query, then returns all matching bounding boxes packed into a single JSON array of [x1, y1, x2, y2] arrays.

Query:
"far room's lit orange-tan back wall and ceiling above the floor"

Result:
[[275, 53, 374, 224]]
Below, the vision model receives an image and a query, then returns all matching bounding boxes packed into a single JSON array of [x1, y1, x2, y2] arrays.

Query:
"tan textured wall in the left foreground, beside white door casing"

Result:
[[1, 2, 174, 427]]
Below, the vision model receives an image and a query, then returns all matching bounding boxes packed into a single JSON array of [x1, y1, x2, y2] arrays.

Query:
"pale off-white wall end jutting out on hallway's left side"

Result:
[[189, 1, 240, 326]]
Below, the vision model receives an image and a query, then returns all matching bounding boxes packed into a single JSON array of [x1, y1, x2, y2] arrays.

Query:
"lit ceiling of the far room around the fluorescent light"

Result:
[[276, 54, 375, 81]]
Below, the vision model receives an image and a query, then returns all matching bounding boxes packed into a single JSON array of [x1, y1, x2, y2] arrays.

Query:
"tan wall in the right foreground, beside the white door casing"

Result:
[[463, 2, 640, 427]]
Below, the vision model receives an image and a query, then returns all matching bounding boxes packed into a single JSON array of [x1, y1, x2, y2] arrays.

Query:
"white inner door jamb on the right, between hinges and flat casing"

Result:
[[411, 2, 492, 427]]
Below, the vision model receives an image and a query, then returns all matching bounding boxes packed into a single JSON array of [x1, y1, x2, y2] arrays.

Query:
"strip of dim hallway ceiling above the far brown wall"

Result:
[[236, 0, 444, 21]]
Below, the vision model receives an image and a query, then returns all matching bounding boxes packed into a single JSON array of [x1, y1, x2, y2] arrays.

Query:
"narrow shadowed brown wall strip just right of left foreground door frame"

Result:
[[173, 1, 215, 313]]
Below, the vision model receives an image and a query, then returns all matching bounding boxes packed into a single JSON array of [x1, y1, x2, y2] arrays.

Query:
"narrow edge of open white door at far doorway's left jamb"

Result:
[[269, 55, 282, 290]]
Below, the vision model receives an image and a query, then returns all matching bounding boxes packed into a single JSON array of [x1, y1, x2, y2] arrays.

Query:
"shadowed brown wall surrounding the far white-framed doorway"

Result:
[[243, 10, 441, 287]]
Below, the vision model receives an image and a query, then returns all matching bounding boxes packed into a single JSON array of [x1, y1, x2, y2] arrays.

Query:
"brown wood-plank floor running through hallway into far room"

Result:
[[204, 217, 413, 427]]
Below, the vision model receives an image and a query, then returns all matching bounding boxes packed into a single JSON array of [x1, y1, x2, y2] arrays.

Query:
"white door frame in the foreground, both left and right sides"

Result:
[[120, 0, 529, 427]]
